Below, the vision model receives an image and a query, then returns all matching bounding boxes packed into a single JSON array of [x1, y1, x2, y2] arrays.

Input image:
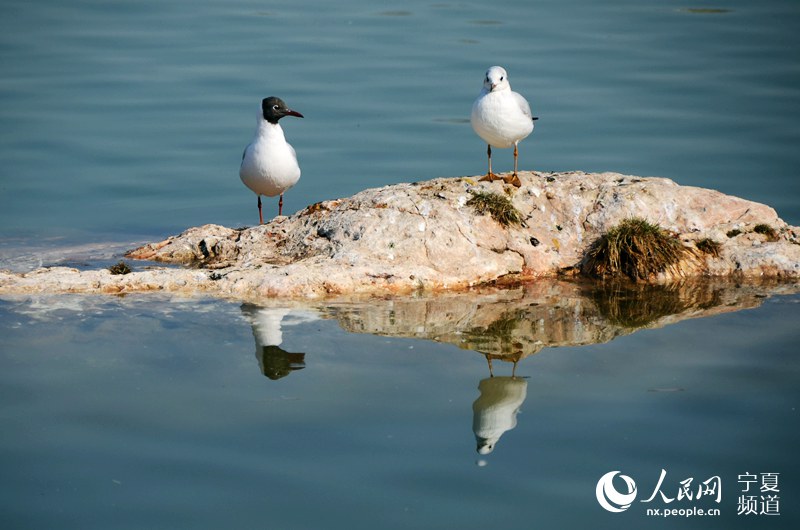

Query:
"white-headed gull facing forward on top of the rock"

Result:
[[470, 66, 538, 187]]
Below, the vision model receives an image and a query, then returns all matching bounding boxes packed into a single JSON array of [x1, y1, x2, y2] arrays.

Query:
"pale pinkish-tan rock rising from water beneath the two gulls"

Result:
[[0, 172, 800, 299]]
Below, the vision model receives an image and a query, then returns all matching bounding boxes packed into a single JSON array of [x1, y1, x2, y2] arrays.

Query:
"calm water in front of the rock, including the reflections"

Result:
[[0, 289, 800, 529]]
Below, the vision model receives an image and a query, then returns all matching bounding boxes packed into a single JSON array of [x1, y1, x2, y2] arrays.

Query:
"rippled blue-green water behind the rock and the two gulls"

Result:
[[0, 0, 800, 244]]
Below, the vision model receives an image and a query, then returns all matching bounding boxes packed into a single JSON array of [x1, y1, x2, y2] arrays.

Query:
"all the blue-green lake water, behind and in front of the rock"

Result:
[[0, 0, 800, 529]]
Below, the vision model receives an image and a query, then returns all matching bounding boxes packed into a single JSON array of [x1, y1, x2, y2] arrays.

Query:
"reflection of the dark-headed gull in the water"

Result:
[[242, 304, 306, 380]]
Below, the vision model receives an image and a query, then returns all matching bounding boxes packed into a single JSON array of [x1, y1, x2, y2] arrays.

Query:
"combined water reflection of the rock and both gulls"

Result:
[[236, 280, 797, 452]]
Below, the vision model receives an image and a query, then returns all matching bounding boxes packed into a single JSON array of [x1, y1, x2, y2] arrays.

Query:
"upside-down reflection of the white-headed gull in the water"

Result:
[[472, 377, 528, 455]]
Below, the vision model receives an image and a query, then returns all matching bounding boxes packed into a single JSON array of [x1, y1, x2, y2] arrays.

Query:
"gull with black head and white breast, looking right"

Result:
[[239, 97, 303, 224]]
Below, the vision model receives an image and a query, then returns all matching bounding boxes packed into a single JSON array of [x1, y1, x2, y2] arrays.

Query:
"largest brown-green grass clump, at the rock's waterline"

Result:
[[581, 217, 687, 281]]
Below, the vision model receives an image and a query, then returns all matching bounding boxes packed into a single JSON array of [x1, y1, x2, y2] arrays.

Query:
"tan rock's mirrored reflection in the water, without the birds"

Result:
[[323, 280, 798, 366]]
